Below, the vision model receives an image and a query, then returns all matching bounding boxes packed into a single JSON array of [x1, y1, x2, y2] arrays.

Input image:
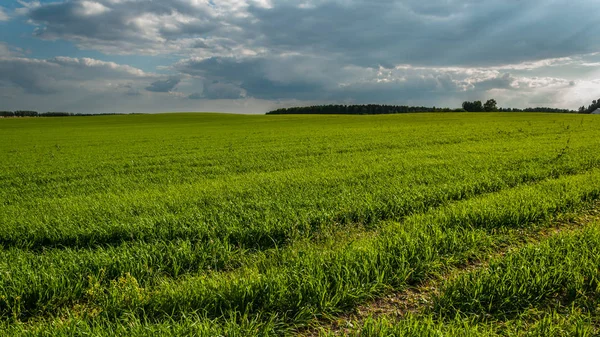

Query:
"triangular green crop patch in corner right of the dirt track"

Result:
[[323, 220, 600, 337]]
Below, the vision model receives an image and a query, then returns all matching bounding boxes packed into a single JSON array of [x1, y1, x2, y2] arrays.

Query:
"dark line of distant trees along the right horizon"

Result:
[[267, 99, 600, 115]]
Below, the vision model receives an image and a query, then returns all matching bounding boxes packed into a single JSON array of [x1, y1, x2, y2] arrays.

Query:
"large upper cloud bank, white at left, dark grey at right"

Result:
[[17, 0, 600, 67]]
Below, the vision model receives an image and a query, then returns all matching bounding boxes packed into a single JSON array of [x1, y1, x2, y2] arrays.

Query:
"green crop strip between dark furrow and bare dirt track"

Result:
[[0, 170, 600, 327]]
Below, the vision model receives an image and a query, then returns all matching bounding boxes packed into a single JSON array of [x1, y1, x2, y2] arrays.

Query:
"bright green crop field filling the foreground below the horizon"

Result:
[[0, 113, 600, 336]]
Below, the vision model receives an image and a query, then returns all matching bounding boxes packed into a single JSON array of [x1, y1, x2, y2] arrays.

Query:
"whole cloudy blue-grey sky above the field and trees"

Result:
[[0, 0, 600, 113]]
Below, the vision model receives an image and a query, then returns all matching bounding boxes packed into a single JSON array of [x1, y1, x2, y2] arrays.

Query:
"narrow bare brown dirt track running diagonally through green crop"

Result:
[[298, 202, 600, 337]]
